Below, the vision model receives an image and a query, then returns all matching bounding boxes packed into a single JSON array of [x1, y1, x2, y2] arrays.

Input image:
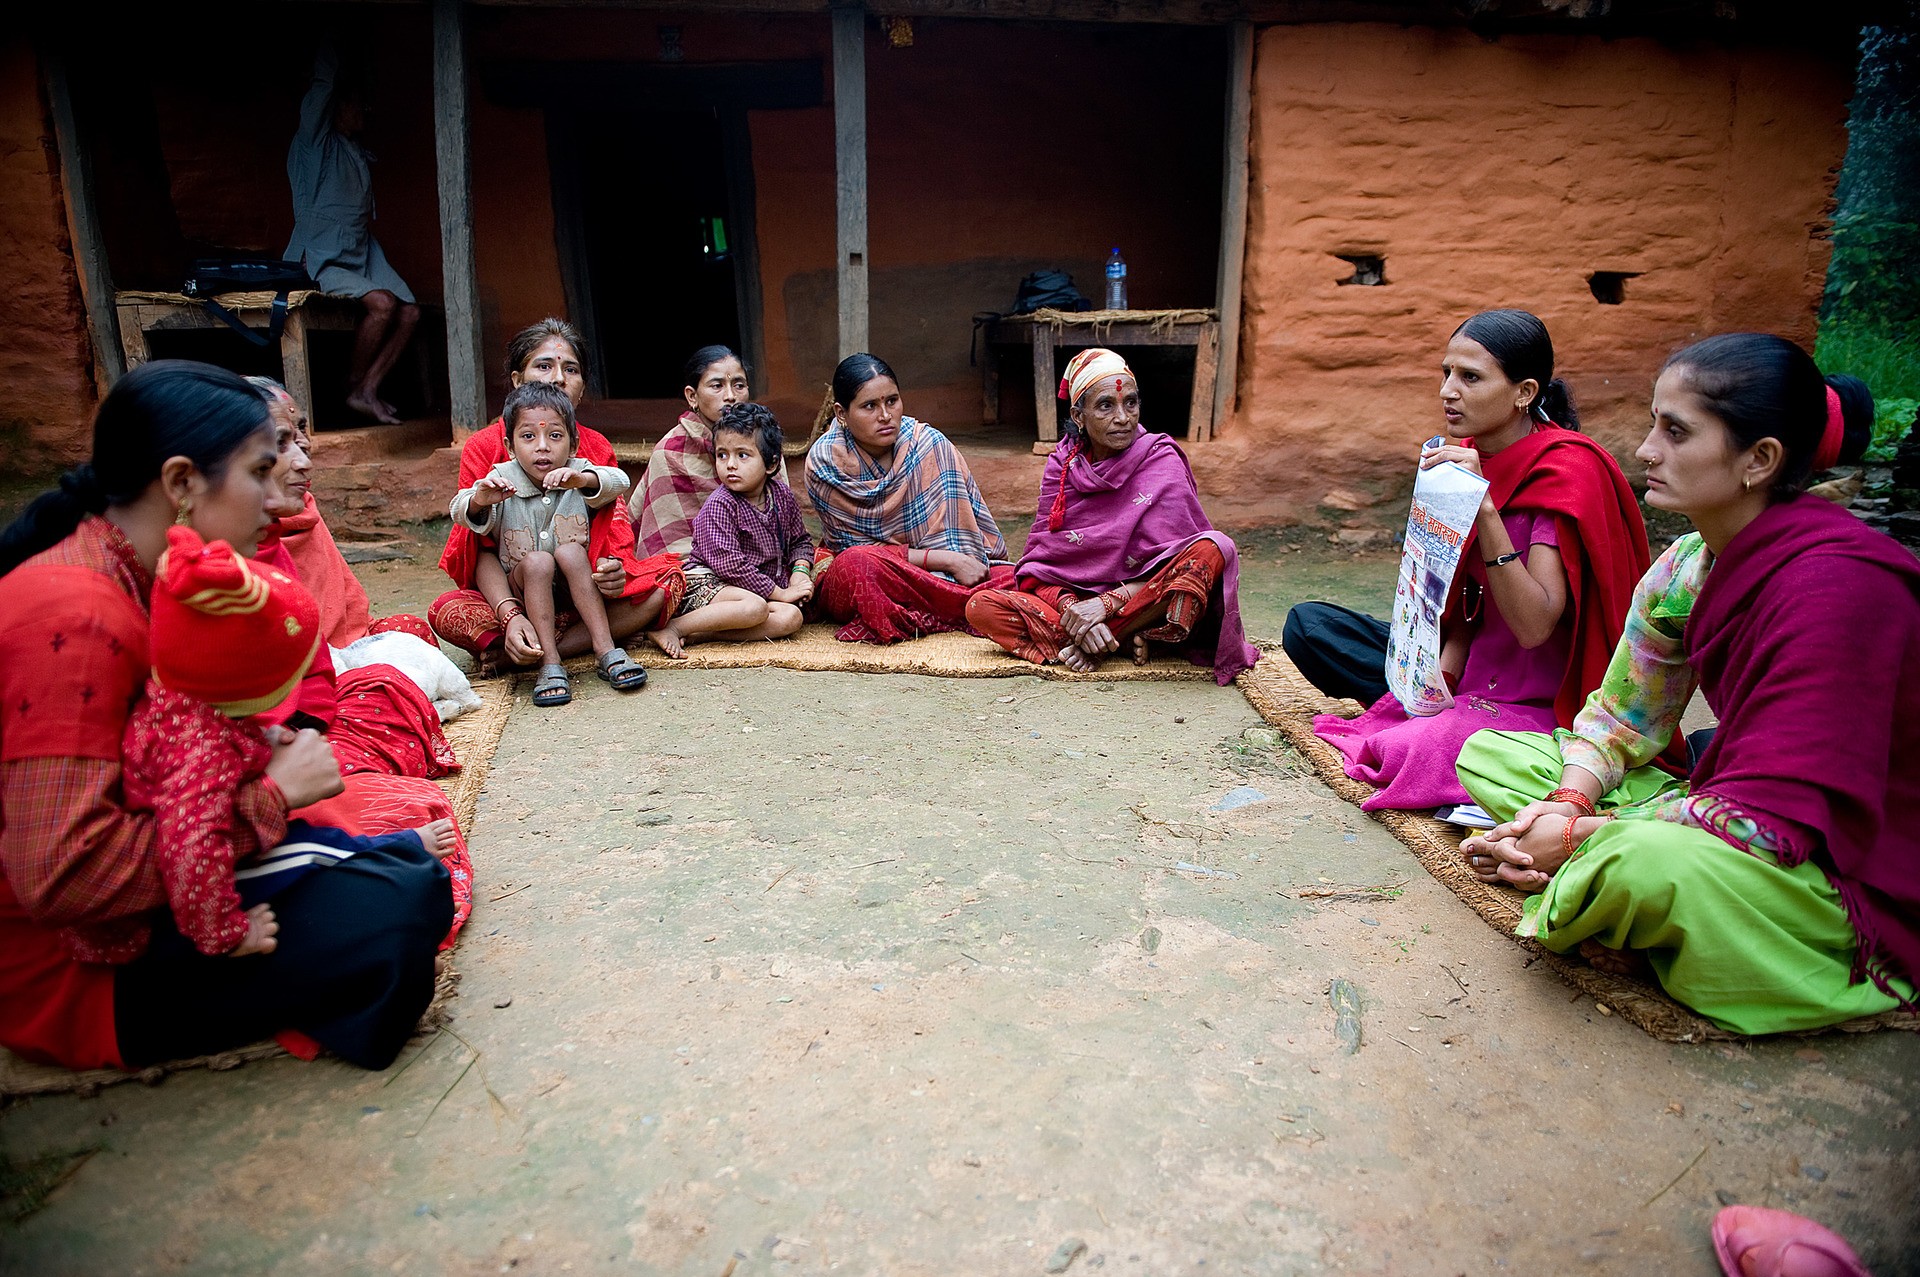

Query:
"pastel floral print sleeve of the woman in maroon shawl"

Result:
[[1553, 532, 1713, 793]]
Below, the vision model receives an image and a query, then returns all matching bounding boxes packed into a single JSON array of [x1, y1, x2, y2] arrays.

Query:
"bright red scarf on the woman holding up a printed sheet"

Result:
[[1448, 424, 1658, 741]]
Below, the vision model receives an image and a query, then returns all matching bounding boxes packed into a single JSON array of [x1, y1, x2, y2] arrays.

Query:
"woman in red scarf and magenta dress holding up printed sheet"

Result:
[[1283, 311, 1649, 810]]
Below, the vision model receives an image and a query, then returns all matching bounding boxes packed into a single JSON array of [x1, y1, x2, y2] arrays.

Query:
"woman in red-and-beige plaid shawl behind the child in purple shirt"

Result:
[[626, 346, 787, 559]]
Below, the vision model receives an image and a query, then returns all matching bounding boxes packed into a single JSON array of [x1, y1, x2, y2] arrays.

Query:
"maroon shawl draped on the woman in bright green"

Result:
[[1686, 494, 1920, 993]]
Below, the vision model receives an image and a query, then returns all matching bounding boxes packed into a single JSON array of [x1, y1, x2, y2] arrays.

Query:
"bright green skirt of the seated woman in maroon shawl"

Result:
[[1459, 732, 1914, 1033]]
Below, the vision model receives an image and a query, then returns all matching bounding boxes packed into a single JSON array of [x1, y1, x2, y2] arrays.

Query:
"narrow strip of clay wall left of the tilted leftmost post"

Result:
[[0, 40, 94, 472]]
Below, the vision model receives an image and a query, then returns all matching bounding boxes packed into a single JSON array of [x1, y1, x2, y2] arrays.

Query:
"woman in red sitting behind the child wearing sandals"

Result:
[[426, 319, 687, 668]]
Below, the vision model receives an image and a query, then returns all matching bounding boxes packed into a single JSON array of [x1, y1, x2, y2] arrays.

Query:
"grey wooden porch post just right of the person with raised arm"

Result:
[[434, 0, 488, 444]]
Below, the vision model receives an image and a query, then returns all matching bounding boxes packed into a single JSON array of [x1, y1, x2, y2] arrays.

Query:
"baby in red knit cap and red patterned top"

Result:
[[63, 526, 455, 962]]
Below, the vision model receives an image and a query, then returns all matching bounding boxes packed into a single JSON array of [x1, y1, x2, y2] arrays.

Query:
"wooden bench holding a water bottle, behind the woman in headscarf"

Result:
[[979, 309, 1219, 444]]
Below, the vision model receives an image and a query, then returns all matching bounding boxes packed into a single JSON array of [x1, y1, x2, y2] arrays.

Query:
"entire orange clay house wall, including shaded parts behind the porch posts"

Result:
[[0, 6, 1849, 522]]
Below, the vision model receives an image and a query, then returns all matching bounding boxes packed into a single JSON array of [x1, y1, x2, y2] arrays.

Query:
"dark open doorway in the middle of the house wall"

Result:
[[574, 108, 741, 399]]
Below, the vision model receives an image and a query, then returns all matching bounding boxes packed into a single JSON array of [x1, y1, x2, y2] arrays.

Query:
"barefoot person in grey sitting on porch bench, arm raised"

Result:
[[286, 46, 420, 422]]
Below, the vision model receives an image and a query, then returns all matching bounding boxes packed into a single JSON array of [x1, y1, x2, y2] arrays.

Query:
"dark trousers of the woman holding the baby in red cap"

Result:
[[113, 839, 453, 1070]]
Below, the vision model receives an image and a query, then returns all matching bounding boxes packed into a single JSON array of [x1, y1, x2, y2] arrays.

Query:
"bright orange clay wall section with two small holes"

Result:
[[1194, 25, 1851, 520]]
